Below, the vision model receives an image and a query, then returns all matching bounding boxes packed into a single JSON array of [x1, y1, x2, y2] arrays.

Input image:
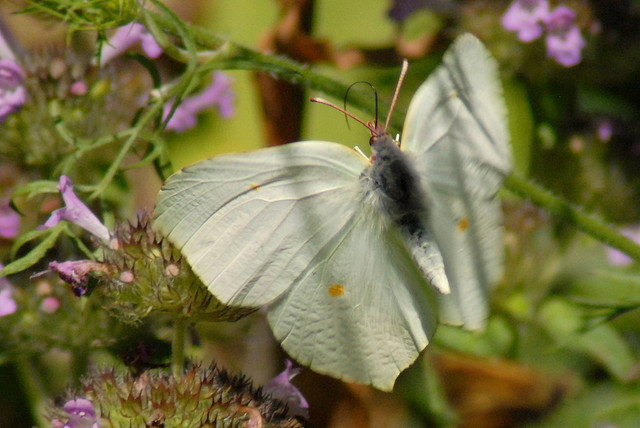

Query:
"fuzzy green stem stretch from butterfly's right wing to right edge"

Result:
[[505, 174, 640, 261]]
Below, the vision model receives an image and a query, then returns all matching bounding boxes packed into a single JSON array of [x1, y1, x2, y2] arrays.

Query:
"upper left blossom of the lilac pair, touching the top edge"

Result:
[[502, 0, 549, 42]]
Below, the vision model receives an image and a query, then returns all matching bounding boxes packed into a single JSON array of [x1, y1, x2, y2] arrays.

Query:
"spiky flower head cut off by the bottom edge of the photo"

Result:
[[52, 365, 304, 428]]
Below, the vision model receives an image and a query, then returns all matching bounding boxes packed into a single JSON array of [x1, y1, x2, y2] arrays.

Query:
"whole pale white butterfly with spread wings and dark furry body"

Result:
[[155, 35, 511, 390]]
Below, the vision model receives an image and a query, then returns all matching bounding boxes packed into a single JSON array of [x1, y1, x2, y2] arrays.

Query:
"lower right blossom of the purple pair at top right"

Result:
[[545, 6, 585, 67]]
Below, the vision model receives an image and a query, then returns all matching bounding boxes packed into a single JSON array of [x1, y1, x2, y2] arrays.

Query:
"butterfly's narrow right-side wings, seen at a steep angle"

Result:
[[402, 35, 512, 329]]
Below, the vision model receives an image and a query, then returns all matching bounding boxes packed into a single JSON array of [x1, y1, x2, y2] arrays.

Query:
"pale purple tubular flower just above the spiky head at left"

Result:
[[38, 175, 111, 241]]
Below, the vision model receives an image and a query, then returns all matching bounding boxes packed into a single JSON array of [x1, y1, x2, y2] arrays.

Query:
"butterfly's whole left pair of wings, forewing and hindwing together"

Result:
[[155, 142, 435, 389]]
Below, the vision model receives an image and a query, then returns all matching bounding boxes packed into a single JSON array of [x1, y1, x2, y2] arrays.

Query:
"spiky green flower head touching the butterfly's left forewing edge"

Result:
[[99, 214, 257, 321]]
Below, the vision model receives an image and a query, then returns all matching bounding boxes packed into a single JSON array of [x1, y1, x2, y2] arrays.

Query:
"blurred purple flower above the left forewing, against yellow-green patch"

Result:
[[163, 73, 235, 132]]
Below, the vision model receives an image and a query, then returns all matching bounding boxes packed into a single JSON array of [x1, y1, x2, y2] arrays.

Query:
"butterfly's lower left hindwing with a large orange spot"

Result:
[[268, 208, 437, 391]]
